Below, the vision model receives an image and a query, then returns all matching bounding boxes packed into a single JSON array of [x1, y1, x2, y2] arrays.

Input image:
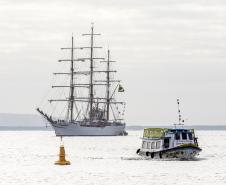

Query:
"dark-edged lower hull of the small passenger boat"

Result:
[[137, 145, 201, 159]]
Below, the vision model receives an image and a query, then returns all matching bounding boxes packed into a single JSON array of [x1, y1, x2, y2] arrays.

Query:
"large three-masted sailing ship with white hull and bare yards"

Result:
[[37, 25, 127, 136]]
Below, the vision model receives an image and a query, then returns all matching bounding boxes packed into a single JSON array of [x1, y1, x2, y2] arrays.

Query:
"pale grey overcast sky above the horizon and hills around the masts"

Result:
[[0, 0, 226, 124]]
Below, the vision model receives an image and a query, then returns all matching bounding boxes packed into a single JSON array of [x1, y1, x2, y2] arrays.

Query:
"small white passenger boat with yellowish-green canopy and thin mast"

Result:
[[137, 99, 202, 159]]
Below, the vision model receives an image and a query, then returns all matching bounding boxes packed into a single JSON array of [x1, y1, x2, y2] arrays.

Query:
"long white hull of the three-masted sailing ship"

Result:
[[51, 123, 127, 136]]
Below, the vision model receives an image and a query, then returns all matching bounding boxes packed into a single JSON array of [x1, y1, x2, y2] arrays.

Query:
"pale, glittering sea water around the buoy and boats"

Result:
[[0, 131, 226, 185]]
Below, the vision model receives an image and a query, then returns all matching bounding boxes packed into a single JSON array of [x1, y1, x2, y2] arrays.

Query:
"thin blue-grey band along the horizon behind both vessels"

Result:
[[0, 125, 226, 131]]
